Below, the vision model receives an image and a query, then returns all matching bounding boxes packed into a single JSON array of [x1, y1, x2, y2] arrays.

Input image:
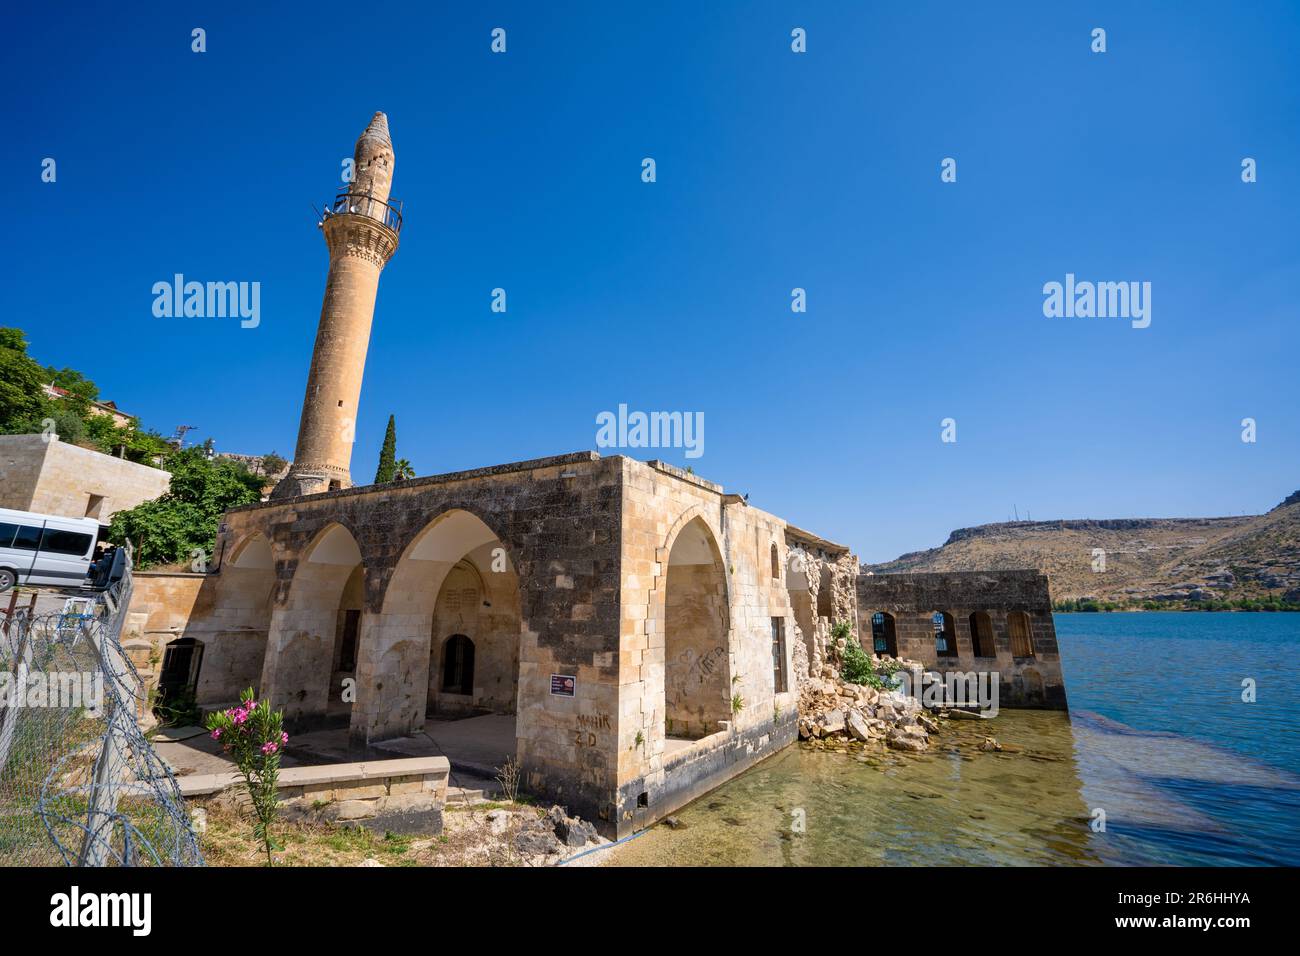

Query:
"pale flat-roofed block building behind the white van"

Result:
[[0, 434, 172, 524]]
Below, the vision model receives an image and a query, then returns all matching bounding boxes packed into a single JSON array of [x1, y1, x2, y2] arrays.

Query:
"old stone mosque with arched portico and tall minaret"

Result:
[[129, 113, 1063, 836]]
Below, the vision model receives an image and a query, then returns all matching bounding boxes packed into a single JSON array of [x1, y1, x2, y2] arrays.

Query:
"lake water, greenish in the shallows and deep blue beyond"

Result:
[[608, 613, 1300, 866]]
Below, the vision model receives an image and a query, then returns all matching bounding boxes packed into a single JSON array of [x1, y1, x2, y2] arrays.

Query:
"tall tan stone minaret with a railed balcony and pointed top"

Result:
[[270, 113, 402, 498]]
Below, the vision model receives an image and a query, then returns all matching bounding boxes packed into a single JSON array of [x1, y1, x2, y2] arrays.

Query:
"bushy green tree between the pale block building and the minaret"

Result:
[[108, 447, 261, 570]]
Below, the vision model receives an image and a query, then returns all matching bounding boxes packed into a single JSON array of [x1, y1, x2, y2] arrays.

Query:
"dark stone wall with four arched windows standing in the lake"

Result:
[[857, 571, 1066, 710]]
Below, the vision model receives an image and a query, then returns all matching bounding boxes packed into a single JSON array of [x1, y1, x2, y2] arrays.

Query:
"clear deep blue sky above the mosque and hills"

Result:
[[0, 0, 1300, 561]]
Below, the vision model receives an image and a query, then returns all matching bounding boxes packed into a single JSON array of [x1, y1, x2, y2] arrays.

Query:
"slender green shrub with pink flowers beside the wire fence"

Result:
[[207, 687, 289, 866]]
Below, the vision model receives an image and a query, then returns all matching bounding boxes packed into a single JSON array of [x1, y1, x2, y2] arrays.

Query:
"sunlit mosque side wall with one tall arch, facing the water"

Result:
[[614, 458, 797, 835]]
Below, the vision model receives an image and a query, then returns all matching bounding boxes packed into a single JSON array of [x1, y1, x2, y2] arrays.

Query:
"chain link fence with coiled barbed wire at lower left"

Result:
[[0, 554, 203, 866]]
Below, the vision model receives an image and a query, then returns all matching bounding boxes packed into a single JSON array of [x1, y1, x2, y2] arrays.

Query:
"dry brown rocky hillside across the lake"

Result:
[[863, 492, 1300, 604]]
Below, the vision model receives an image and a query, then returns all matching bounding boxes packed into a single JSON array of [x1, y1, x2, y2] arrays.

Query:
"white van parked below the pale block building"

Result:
[[0, 507, 100, 592]]
